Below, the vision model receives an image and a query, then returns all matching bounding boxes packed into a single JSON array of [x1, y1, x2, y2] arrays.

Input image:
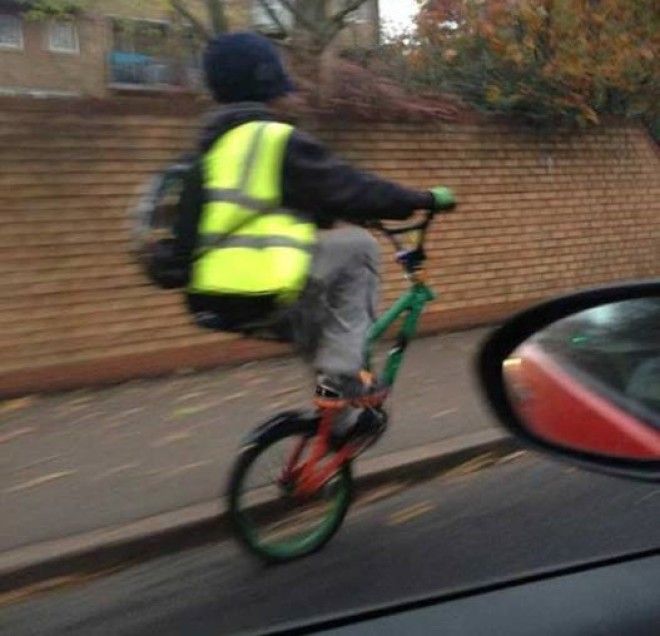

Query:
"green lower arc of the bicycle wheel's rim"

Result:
[[237, 471, 351, 561]]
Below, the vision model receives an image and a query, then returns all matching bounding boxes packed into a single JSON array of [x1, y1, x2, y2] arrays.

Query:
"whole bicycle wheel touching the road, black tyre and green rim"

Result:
[[228, 414, 352, 563]]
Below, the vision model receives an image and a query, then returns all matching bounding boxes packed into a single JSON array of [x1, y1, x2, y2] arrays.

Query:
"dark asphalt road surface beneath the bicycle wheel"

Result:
[[5, 453, 660, 636]]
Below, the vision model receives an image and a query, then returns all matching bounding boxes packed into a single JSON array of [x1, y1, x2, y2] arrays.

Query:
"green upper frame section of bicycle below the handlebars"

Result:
[[365, 281, 436, 386]]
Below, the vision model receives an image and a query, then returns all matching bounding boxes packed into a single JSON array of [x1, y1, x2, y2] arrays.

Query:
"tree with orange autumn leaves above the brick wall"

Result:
[[408, 0, 660, 130]]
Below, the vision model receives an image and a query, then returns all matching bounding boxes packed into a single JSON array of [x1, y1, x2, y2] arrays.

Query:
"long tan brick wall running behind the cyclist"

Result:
[[0, 99, 660, 396]]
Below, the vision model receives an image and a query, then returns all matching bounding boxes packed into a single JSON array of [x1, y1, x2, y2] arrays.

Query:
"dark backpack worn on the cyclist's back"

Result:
[[133, 155, 196, 289]]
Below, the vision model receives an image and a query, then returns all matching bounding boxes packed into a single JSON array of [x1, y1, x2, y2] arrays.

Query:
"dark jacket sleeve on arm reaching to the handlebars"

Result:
[[283, 130, 435, 225]]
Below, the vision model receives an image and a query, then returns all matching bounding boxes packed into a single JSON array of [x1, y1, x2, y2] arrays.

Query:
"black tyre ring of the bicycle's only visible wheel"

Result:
[[227, 414, 353, 564]]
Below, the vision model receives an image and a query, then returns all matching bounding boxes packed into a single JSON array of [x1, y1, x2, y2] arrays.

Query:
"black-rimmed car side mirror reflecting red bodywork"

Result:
[[477, 281, 660, 480]]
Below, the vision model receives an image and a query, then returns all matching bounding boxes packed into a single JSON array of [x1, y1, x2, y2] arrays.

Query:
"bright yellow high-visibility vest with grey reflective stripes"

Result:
[[189, 122, 316, 301]]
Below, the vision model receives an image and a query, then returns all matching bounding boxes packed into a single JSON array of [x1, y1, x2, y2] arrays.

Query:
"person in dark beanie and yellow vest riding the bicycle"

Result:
[[176, 33, 453, 424]]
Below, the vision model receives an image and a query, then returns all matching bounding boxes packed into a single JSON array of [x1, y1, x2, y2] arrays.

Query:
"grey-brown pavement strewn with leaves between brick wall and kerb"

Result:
[[0, 329, 494, 553]]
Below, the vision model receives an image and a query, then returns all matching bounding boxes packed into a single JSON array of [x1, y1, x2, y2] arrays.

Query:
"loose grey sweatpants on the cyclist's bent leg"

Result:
[[288, 226, 379, 376]]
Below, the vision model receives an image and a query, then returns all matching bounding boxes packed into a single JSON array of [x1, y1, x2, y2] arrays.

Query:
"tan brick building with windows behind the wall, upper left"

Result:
[[0, 0, 379, 98]]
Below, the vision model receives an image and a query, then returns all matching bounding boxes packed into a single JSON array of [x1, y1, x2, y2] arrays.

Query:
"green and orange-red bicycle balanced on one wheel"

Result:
[[227, 213, 444, 563]]
